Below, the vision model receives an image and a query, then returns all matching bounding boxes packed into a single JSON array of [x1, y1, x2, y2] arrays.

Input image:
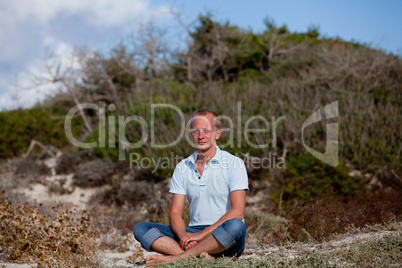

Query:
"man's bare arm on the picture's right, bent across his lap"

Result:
[[179, 190, 246, 248]]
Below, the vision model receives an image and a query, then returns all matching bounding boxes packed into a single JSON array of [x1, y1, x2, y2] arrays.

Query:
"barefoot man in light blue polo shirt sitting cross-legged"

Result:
[[134, 109, 248, 266]]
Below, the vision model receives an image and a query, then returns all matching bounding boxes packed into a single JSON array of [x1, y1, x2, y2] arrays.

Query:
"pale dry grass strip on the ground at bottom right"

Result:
[[164, 224, 402, 268]]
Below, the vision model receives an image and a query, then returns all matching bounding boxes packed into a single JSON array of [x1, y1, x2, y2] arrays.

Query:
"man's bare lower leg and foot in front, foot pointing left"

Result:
[[146, 234, 225, 266]]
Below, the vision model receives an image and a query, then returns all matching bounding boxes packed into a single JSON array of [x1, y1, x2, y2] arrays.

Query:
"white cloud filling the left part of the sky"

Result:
[[0, 0, 171, 110]]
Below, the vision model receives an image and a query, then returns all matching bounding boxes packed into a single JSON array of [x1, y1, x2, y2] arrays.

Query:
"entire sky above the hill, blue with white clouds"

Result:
[[0, 0, 402, 110]]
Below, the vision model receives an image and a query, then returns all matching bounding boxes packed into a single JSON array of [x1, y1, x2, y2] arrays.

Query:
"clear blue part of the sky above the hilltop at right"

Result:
[[159, 0, 402, 54]]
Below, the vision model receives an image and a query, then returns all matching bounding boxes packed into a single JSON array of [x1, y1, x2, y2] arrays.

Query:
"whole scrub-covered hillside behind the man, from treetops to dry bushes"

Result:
[[0, 15, 402, 267]]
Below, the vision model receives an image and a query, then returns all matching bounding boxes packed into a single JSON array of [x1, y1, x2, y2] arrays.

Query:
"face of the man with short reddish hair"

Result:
[[191, 114, 221, 152]]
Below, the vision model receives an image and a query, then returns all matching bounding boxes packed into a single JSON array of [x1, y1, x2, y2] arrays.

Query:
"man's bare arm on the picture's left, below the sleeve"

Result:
[[169, 194, 186, 239]]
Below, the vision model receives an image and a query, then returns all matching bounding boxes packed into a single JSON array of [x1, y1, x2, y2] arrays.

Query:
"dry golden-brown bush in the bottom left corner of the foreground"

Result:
[[0, 191, 98, 267]]
